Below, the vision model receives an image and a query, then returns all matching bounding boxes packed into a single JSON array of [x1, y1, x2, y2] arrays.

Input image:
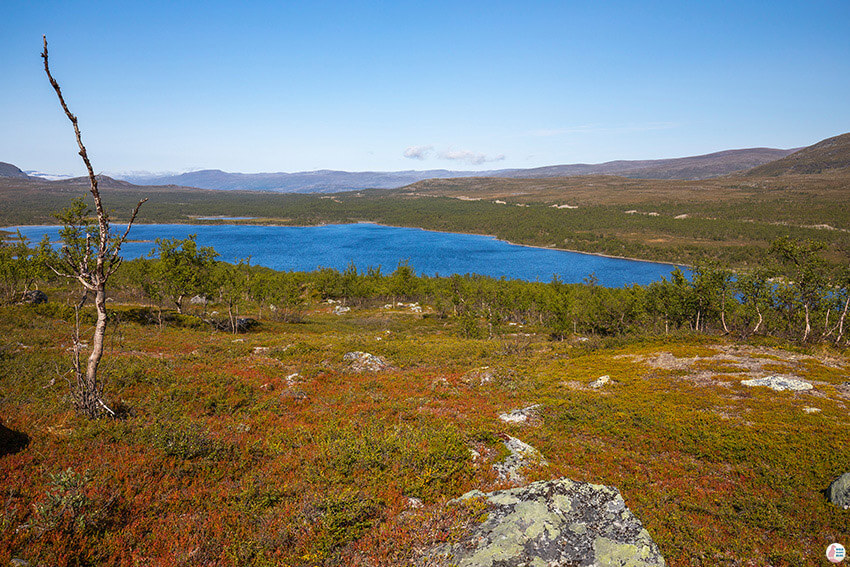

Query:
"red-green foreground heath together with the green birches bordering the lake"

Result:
[[0, 227, 850, 566]]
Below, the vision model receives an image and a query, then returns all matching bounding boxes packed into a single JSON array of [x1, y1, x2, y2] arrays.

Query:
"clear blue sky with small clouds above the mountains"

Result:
[[0, 0, 850, 174]]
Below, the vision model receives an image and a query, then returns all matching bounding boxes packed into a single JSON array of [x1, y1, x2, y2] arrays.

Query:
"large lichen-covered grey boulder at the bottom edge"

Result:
[[432, 478, 665, 567]]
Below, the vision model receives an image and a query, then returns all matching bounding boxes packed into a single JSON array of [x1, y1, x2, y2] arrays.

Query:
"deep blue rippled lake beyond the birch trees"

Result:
[[6, 223, 674, 287]]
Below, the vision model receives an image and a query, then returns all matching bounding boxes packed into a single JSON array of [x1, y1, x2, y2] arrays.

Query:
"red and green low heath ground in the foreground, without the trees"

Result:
[[0, 304, 850, 566]]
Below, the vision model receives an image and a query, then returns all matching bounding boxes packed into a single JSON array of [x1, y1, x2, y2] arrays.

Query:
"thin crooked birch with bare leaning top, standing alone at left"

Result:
[[41, 36, 147, 417]]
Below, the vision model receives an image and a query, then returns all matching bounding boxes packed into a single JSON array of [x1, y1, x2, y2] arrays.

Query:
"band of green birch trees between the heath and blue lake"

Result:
[[0, 229, 850, 347]]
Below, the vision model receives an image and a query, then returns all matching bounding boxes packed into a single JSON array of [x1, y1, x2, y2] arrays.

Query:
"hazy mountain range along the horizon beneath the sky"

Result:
[[0, 134, 850, 193]]
